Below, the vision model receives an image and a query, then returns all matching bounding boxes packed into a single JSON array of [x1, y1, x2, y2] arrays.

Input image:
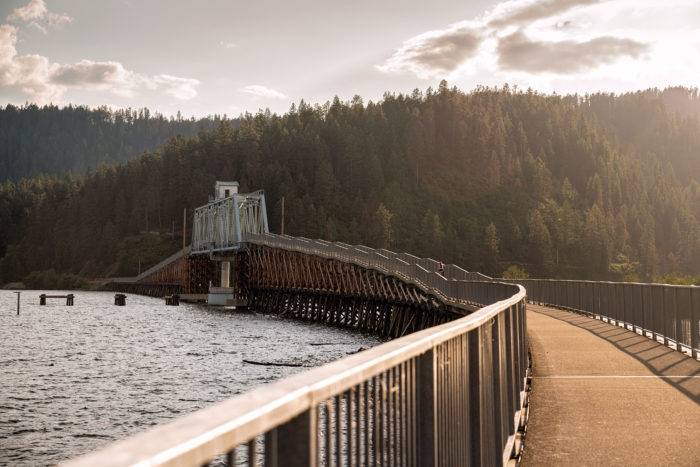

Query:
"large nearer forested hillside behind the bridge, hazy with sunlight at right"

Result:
[[0, 83, 700, 288]]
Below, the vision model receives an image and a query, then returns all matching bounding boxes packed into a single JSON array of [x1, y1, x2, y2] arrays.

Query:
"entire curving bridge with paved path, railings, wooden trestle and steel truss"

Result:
[[72, 185, 700, 467]]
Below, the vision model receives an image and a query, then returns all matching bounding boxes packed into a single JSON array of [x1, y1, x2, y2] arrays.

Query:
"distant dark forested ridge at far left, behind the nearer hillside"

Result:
[[0, 105, 228, 181]]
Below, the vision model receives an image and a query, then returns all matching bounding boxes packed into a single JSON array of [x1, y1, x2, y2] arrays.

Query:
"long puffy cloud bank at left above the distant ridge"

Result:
[[0, 24, 200, 103]]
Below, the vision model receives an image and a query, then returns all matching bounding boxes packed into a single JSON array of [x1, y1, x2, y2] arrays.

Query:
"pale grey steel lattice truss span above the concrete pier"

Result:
[[191, 191, 268, 253]]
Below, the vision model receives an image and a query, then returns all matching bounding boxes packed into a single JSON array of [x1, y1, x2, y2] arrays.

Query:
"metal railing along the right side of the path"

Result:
[[509, 279, 700, 359]]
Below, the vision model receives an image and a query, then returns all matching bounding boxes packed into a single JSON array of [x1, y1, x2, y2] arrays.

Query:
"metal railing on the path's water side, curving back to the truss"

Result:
[[67, 235, 528, 467]]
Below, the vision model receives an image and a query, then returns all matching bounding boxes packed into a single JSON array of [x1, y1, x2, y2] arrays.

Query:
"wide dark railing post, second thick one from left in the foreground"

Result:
[[416, 348, 437, 467]]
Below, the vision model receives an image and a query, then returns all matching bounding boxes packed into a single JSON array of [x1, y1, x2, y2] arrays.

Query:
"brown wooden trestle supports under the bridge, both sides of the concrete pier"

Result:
[[106, 240, 466, 337]]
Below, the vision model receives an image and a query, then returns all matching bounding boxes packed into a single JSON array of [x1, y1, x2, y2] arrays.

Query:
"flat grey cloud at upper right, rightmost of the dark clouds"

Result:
[[498, 31, 648, 74]]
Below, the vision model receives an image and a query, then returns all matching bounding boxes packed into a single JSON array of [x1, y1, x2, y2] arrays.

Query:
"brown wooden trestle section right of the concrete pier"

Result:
[[242, 245, 462, 338]]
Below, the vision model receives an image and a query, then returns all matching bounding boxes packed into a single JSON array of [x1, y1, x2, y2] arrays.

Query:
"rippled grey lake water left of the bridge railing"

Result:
[[0, 291, 380, 465]]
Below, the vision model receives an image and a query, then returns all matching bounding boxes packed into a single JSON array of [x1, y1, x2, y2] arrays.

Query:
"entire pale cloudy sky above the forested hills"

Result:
[[0, 0, 700, 116]]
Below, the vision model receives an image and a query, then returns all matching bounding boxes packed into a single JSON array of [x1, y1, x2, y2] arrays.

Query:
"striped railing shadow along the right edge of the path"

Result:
[[528, 305, 700, 404]]
